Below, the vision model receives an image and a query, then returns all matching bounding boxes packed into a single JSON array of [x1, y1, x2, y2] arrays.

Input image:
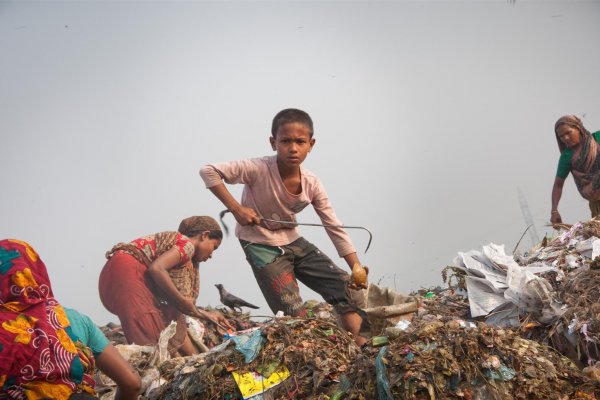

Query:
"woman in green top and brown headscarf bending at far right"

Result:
[[550, 115, 600, 224]]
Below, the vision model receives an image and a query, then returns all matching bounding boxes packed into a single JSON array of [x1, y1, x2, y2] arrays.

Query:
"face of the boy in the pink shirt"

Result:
[[269, 122, 315, 168]]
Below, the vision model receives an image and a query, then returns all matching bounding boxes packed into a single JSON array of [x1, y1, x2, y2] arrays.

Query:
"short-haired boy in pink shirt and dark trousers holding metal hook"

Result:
[[200, 109, 366, 345]]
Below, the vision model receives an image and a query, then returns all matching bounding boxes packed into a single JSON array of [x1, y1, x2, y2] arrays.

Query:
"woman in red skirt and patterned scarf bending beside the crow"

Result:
[[99, 216, 234, 355]]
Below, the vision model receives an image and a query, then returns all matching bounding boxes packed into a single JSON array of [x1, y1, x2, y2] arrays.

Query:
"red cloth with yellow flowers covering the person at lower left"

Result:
[[0, 239, 95, 400]]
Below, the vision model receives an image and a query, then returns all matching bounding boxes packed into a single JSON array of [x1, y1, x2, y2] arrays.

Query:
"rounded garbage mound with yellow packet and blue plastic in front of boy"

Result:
[[147, 317, 360, 400]]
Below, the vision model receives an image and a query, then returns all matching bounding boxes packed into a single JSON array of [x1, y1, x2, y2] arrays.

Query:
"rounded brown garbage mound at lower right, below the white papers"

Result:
[[344, 314, 598, 400]]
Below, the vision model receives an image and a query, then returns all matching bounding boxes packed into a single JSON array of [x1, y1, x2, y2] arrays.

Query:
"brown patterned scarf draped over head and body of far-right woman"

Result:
[[554, 115, 600, 201]]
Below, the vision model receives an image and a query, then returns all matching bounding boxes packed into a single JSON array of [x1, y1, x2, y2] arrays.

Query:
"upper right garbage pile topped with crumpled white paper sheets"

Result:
[[444, 219, 600, 375]]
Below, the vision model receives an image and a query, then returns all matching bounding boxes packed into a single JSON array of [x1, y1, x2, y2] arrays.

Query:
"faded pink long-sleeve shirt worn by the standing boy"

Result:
[[200, 156, 356, 257]]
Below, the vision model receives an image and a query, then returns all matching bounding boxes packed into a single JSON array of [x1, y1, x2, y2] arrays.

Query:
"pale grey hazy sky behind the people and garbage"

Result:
[[0, 0, 600, 324]]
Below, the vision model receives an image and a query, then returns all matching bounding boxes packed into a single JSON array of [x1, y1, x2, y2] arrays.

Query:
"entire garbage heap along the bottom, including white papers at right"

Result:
[[92, 220, 600, 400]]
